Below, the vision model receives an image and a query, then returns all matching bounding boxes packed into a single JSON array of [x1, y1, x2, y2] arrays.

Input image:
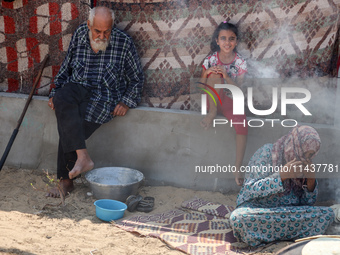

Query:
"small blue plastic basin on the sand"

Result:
[[94, 199, 127, 221]]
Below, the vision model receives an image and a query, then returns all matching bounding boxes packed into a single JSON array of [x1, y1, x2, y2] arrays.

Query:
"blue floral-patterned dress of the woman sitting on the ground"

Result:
[[230, 144, 334, 246]]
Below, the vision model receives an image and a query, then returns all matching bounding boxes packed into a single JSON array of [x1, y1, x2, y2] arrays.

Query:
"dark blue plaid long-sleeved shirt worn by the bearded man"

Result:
[[50, 23, 144, 124]]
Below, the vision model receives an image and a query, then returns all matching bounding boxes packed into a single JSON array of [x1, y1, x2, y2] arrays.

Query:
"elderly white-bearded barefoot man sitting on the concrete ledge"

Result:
[[47, 7, 144, 197]]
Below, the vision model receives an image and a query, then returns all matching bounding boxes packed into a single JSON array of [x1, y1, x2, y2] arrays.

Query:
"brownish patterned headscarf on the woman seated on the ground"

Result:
[[272, 126, 321, 193]]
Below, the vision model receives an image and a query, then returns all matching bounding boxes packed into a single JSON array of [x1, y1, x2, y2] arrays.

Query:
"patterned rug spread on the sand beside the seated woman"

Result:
[[114, 198, 246, 255]]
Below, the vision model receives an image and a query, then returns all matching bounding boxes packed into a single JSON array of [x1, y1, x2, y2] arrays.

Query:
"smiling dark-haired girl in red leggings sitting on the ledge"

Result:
[[201, 21, 248, 186]]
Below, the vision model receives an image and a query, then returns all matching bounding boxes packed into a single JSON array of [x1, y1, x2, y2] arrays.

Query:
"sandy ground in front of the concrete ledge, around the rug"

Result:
[[0, 167, 289, 255]]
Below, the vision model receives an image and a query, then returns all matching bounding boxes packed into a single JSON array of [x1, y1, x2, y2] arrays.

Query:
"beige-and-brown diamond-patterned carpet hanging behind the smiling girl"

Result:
[[98, 0, 340, 112]]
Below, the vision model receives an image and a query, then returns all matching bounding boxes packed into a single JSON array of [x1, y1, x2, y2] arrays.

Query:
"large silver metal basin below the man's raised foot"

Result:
[[85, 167, 144, 202]]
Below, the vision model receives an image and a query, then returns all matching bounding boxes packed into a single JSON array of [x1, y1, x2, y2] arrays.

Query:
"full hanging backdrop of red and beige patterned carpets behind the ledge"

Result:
[[0, 0, 340, 117]]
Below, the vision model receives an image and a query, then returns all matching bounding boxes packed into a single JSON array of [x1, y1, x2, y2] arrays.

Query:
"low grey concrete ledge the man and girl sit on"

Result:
[[0, 93, 340, 198]]
